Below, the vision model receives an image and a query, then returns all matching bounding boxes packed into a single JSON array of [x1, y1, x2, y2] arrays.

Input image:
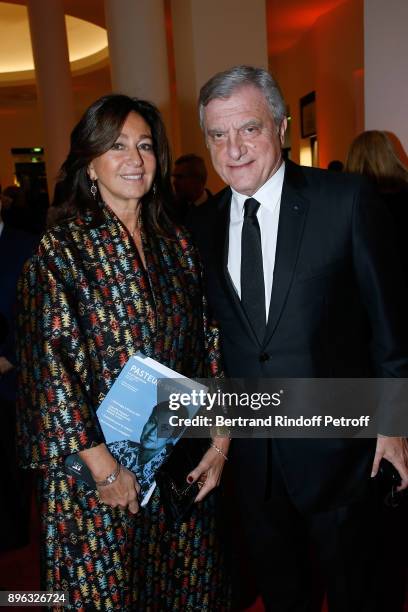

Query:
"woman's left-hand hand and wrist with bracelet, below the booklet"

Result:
[[79, 444, 140, 514]]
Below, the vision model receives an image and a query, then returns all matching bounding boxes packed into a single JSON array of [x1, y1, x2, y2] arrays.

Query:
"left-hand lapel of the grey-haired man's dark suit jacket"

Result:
[[217, 189, 260, 344]]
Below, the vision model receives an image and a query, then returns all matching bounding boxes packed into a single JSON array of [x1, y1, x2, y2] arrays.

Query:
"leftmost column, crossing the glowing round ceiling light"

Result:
[[27, 0, 74, 197]]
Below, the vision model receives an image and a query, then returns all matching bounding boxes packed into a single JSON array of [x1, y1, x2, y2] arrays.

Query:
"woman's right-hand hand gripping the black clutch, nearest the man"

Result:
[[187, 437, 231, 502]]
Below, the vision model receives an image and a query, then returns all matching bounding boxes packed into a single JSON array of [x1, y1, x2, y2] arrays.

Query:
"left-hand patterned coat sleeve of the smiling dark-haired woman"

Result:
[[17, 235, 104, 468]]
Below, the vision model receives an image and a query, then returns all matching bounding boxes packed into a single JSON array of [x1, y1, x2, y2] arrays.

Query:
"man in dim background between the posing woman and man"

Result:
[[173, 153, 212, 220]]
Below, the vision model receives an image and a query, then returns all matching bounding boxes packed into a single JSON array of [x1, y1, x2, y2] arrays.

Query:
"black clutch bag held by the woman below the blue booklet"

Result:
[[155, 438, 208, 521]]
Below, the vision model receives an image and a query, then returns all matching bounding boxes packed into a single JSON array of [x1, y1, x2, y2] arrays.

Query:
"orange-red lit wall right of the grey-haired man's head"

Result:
[[270, 0, 364, 168]]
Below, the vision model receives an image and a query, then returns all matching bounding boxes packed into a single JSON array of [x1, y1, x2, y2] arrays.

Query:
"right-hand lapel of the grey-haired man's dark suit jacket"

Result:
[[264, 162, 309, 344]]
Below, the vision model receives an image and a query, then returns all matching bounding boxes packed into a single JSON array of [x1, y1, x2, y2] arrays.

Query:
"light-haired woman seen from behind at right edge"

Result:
[[345, 130, 408, 278]]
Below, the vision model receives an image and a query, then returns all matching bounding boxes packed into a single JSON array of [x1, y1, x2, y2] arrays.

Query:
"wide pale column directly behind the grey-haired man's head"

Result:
[[171, 0, 268, 190]]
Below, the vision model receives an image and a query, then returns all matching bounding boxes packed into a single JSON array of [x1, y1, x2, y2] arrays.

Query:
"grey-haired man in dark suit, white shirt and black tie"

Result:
[[191, 66, 408, 612]]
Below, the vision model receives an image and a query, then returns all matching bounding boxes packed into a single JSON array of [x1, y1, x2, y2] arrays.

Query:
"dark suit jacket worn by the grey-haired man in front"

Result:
[[190, 162, 408, 510]]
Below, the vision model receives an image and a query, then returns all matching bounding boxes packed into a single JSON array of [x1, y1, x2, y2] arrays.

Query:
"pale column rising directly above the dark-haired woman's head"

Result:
[[105, 0, 170, 127]]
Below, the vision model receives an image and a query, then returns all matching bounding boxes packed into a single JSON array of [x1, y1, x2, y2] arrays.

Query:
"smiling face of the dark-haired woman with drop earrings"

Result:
[[88, 112, 156, 210]]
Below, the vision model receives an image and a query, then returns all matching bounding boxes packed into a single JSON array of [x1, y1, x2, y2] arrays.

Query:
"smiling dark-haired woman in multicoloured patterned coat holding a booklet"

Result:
[[18, 95, 229, 611]]
